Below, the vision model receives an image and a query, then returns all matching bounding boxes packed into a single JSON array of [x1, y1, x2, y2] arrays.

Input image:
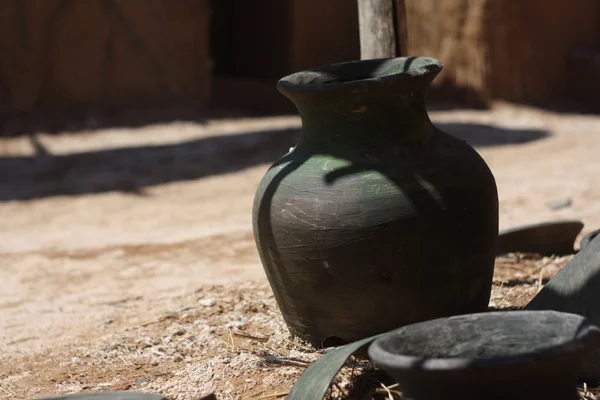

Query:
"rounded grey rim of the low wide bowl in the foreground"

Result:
[[368, 310, 600, 372]]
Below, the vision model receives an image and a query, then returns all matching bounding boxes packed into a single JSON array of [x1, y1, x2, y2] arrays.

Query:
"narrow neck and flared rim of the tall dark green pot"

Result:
[[278, 57, 441, 147]]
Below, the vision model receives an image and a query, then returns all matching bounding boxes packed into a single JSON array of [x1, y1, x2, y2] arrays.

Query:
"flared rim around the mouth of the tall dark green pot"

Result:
[[277, 56, 443, 93]]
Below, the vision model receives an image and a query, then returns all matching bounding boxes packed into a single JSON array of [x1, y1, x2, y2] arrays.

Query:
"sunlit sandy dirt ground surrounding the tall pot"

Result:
[[0, 104, 600, 400]]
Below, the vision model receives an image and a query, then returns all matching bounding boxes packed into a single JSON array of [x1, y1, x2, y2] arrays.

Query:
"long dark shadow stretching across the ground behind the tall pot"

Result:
[[0, 123, 548, 201]]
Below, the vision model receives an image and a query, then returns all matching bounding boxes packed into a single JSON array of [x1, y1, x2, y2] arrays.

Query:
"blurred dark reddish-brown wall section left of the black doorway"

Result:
[[0, 0, 211, 115]]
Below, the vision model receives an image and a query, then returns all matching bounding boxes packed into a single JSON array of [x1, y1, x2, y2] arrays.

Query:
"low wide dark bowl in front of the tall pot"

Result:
[[369, 311, 600, 400]]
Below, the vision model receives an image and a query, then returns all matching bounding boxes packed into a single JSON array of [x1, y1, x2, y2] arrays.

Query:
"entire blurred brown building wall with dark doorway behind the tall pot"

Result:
[[0, 0, 600, 126]]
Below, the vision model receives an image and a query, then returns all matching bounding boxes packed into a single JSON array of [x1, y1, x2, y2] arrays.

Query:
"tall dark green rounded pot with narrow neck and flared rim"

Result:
[[253, 57, 498, 345]]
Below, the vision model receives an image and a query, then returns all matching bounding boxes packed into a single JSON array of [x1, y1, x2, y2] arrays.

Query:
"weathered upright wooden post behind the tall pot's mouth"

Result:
[[358, 0, 406, 60]]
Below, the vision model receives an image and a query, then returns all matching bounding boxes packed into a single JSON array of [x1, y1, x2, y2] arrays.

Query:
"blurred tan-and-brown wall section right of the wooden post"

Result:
[[406, 0, 600, 106]]
